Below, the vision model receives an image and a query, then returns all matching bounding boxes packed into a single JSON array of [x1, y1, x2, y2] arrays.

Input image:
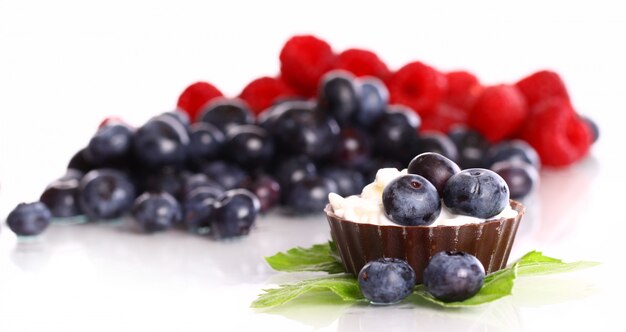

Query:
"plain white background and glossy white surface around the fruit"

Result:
[[0, 0, 626, 332]]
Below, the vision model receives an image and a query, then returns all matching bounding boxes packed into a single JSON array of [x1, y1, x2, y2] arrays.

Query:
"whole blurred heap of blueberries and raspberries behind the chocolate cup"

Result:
[[7, 36, 598, 239]]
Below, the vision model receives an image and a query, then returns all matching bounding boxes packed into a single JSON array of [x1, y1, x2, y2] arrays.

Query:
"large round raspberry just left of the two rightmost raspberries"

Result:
[[469, 84, 528, 143]]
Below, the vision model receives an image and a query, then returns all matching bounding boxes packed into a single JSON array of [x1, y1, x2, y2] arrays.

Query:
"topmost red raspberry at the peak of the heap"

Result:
[[280, 35, 336, 97]]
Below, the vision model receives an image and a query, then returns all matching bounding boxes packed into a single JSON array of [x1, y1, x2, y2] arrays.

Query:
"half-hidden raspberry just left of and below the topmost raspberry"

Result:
[[239, 76, 294, 114]]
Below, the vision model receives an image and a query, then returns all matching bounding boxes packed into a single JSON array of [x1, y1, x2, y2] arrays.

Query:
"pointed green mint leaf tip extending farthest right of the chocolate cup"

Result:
[[517, 251, 600, 276]]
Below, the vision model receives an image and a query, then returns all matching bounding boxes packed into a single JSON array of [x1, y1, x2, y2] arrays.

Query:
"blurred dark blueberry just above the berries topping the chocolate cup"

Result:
[[373, 105, 421, 164]]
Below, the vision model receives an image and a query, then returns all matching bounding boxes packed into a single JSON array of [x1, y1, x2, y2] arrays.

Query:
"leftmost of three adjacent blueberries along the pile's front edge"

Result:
[[132, 192, 182, 233]]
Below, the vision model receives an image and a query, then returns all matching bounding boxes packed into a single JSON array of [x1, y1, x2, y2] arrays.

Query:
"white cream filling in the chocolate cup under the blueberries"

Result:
[[328, 168, 517, 227]]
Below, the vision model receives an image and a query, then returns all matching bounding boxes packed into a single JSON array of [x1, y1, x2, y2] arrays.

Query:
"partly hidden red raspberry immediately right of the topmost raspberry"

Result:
[[336, 48, 391, 81]]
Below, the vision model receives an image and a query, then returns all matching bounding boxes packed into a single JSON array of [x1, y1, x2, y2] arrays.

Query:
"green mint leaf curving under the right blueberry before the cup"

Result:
[[414, 264, 517, 308]]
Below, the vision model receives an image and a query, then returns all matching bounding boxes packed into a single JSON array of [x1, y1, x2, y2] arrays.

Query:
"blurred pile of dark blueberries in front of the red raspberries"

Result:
[[4, 71, 539, 239]]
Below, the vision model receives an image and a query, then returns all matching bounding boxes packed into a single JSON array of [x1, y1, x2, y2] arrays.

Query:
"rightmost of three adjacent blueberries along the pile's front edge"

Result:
[[210, 189, 260, 239]]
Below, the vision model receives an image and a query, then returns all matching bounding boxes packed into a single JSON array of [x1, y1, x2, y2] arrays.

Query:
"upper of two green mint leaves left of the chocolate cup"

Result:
[[265, 242, 346, 274]]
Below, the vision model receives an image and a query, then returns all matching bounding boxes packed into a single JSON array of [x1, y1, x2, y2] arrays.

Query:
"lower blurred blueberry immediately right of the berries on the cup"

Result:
[[491, 160, 539, 199]]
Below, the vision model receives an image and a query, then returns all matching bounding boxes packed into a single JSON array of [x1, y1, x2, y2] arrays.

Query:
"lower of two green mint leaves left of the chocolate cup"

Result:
[[252, 274, 363, 308]]
